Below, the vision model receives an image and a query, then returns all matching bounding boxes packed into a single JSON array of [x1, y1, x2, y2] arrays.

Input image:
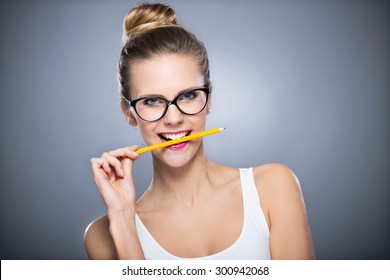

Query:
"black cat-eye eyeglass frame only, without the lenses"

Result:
[[122, 87, 211, 122]]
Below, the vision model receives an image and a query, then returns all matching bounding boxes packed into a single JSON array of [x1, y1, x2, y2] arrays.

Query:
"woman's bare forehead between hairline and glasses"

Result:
[[130, 54, 204, 98]]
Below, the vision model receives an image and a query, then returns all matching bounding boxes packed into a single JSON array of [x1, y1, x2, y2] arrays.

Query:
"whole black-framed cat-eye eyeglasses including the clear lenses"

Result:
[[122, 87, 210, 122]]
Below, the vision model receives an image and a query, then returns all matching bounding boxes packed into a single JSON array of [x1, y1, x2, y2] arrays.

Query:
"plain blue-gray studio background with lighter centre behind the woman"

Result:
[[0, 0, 390, 259]]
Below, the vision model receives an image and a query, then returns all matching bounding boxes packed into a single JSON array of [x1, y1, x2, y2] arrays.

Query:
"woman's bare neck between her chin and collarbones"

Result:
[[150, 145, 212, 207]]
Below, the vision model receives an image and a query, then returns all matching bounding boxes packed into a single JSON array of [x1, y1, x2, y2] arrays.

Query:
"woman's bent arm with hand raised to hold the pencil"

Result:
[[84, 146, 145, 259]]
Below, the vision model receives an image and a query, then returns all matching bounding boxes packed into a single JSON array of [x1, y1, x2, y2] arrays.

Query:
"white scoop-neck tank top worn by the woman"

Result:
[[135, 168, 271, 260]]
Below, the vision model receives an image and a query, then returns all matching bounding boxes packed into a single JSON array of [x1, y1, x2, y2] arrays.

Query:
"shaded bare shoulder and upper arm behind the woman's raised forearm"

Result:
[[84, 215, 117, 260]]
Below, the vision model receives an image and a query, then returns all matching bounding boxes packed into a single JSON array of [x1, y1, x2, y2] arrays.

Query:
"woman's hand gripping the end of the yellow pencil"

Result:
[[91, 145, 139, 213]]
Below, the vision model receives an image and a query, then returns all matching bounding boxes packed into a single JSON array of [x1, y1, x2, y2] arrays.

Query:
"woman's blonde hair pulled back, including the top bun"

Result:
[[118, 3, 211, 100]]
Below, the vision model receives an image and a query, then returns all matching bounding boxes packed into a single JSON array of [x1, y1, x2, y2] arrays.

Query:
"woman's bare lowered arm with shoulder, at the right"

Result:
[[255, 164, 315, 259]]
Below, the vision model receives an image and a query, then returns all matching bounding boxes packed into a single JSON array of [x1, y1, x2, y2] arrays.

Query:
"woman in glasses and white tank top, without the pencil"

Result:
[[85, 4, 314, 259]]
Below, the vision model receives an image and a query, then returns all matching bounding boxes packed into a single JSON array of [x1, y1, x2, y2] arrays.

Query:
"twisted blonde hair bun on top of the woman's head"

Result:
[[123, 3, 177, 41]]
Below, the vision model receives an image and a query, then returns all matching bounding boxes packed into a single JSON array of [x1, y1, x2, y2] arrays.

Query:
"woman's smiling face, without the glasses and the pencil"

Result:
[[130, 54, 210, 167]]
